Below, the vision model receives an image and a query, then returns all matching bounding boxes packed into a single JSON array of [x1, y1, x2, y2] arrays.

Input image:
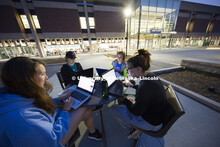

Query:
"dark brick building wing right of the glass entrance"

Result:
[[172, 1, 220, 47]]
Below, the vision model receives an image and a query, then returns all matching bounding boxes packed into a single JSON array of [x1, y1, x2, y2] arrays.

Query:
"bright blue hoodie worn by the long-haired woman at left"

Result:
[[0, 89, 71, 147]]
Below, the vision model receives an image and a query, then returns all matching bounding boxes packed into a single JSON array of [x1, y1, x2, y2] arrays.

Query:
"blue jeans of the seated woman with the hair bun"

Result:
[[111, 105, 162, 131]]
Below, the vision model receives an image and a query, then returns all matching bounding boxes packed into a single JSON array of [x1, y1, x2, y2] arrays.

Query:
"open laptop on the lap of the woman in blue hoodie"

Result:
[[63, 76, 95, 109]]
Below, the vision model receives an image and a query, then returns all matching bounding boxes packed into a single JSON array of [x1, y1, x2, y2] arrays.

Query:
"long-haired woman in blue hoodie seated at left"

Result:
[[0, 57, 101, 147]]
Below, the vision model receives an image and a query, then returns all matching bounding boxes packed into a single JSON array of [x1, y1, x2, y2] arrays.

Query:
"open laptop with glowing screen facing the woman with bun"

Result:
[[102, 69, 123, 96]]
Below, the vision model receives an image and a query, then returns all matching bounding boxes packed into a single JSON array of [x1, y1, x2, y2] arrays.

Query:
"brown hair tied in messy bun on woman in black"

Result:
[[127, 49, 151, 71]]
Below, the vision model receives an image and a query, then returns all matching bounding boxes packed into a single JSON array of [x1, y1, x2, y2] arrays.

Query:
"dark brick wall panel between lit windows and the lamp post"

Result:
[[94, 11, 125, 32]]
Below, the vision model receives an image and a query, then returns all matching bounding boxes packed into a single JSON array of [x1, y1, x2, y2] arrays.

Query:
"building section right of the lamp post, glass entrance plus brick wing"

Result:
[[128, 0, 220, 50]]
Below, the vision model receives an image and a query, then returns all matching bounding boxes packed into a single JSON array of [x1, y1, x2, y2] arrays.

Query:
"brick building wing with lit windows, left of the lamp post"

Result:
[[0, 0, 129, 59]]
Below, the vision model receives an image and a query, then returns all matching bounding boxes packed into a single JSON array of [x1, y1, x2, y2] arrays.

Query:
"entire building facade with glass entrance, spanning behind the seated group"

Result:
[[0, 0, 220, 59]]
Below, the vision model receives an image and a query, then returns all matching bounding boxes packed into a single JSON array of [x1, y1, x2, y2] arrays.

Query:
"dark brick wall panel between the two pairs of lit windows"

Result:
[[35, 8, 81, 32]]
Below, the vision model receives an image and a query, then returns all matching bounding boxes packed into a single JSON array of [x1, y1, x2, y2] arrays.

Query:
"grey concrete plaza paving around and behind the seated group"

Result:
[[47, 49, 220, 147]]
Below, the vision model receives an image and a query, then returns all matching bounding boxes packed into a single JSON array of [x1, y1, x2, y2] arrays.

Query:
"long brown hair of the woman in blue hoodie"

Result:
[[1, 57, 56, 114]]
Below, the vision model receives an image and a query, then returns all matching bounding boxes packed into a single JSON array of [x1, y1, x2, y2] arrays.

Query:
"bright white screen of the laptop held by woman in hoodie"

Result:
[[78, 76, 95, 92]]
